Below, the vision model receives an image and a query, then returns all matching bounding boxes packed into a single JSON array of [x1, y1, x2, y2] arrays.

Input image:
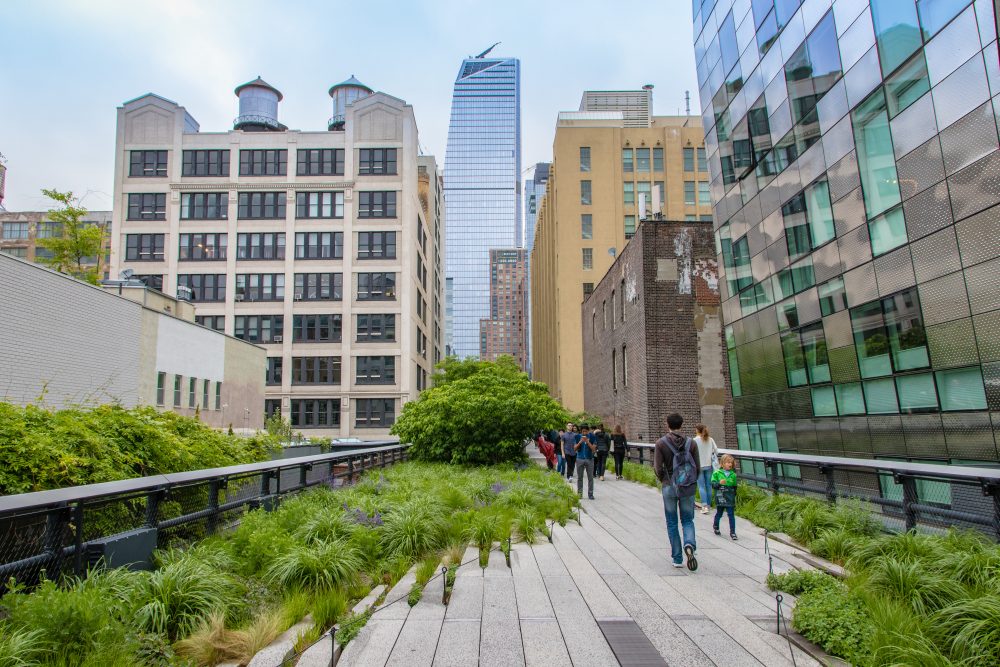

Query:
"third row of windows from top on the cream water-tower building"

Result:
[[125, 232, 396, 262]]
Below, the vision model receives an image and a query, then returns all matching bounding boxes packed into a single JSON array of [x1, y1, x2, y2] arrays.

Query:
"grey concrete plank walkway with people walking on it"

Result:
[[338, 460, 819, 667]]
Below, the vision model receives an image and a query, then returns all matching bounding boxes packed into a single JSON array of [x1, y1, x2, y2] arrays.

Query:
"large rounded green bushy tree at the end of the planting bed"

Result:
[[392, 359, 567, 465]]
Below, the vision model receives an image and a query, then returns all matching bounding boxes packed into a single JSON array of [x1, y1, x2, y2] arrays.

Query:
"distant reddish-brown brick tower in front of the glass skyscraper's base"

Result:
[[479, 248, 528, 371]]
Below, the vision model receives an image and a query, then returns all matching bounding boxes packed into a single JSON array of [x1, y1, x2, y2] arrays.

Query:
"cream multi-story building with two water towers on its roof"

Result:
[[111, 78, 444, 437]]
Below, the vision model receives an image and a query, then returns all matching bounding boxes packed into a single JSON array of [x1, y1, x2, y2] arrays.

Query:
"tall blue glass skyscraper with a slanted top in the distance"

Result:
[[444, 57, 521, 357]]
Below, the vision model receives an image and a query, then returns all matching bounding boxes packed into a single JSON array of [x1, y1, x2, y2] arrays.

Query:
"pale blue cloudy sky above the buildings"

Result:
[[0, 0, 698, 211]]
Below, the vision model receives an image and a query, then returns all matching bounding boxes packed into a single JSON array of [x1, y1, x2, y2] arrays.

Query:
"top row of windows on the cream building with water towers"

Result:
[[128, 148, 398, 178]]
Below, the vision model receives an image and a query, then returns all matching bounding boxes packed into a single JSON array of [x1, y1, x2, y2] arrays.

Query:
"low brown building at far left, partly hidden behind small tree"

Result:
[[0, 211, 111, 278]]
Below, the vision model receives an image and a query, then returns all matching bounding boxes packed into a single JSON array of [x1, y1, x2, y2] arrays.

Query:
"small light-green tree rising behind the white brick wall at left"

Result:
[[38, 190, 105, 285]]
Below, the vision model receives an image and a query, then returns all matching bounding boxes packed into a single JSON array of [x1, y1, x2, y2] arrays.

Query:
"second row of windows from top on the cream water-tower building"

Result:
[[131, 190, 396, 220]]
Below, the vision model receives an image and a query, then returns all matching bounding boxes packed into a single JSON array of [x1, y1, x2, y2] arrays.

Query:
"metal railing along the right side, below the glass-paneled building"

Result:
[[626, 442, 1000, 540]]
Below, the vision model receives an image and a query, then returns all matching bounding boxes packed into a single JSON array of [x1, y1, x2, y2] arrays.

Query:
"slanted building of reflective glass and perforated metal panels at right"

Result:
[[694, 0, 1000, 468]]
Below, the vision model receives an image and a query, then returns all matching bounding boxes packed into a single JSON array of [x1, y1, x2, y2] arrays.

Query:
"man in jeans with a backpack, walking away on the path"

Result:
[[653, 412, 698, 572]]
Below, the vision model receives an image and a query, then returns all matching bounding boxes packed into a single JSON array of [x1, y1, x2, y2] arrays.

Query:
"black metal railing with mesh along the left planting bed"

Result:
[[0, 442, 409, 584]]
